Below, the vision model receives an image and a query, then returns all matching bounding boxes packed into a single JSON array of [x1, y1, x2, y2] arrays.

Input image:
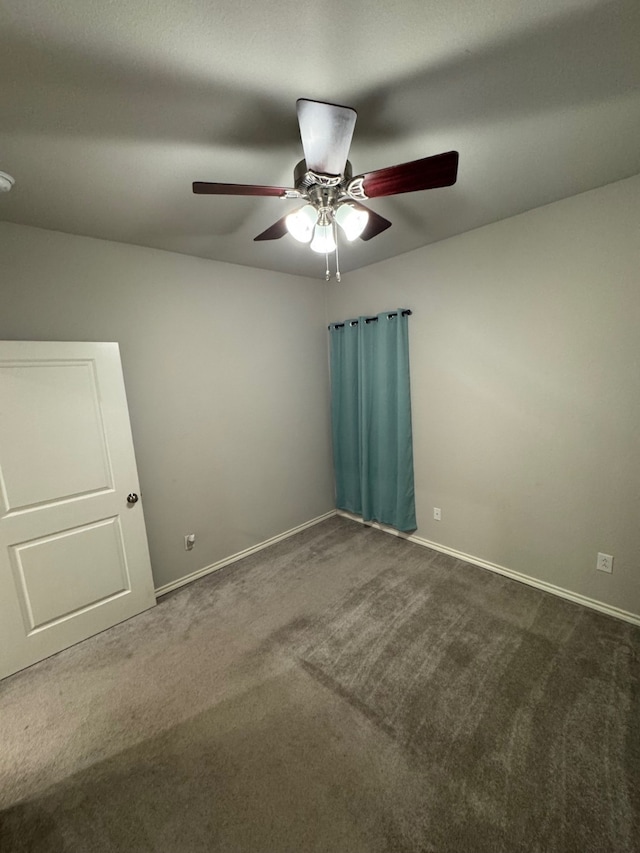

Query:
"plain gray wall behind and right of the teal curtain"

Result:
[[327, 177, 640, 614]]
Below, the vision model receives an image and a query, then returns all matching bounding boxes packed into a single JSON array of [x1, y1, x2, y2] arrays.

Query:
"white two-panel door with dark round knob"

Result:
[[0, 341, 155, 678]]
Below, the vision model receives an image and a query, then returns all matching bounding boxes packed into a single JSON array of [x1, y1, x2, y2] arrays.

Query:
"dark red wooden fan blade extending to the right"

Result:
[[347, 151, 458, 199]]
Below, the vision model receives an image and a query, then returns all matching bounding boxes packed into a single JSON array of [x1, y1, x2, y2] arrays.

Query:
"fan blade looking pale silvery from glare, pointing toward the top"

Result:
[[296, 98, 358, 175]]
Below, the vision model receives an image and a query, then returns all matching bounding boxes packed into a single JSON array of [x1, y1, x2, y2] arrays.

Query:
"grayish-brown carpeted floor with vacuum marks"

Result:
[[0, 518, 640, 853]]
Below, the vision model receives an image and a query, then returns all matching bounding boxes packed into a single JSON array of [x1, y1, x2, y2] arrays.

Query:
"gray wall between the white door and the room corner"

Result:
[[0, 223, 333, 586]]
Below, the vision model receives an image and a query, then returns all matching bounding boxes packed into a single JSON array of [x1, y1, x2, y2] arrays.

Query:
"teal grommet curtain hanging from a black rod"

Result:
[[329, 308, 416, 531]]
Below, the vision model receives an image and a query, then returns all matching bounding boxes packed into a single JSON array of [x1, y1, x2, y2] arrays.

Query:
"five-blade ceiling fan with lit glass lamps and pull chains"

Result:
[[193, 98, 458, 281]]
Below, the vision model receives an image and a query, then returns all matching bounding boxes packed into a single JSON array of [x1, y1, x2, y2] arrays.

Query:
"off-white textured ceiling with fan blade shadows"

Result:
[[0, 0, 640, 278]]
